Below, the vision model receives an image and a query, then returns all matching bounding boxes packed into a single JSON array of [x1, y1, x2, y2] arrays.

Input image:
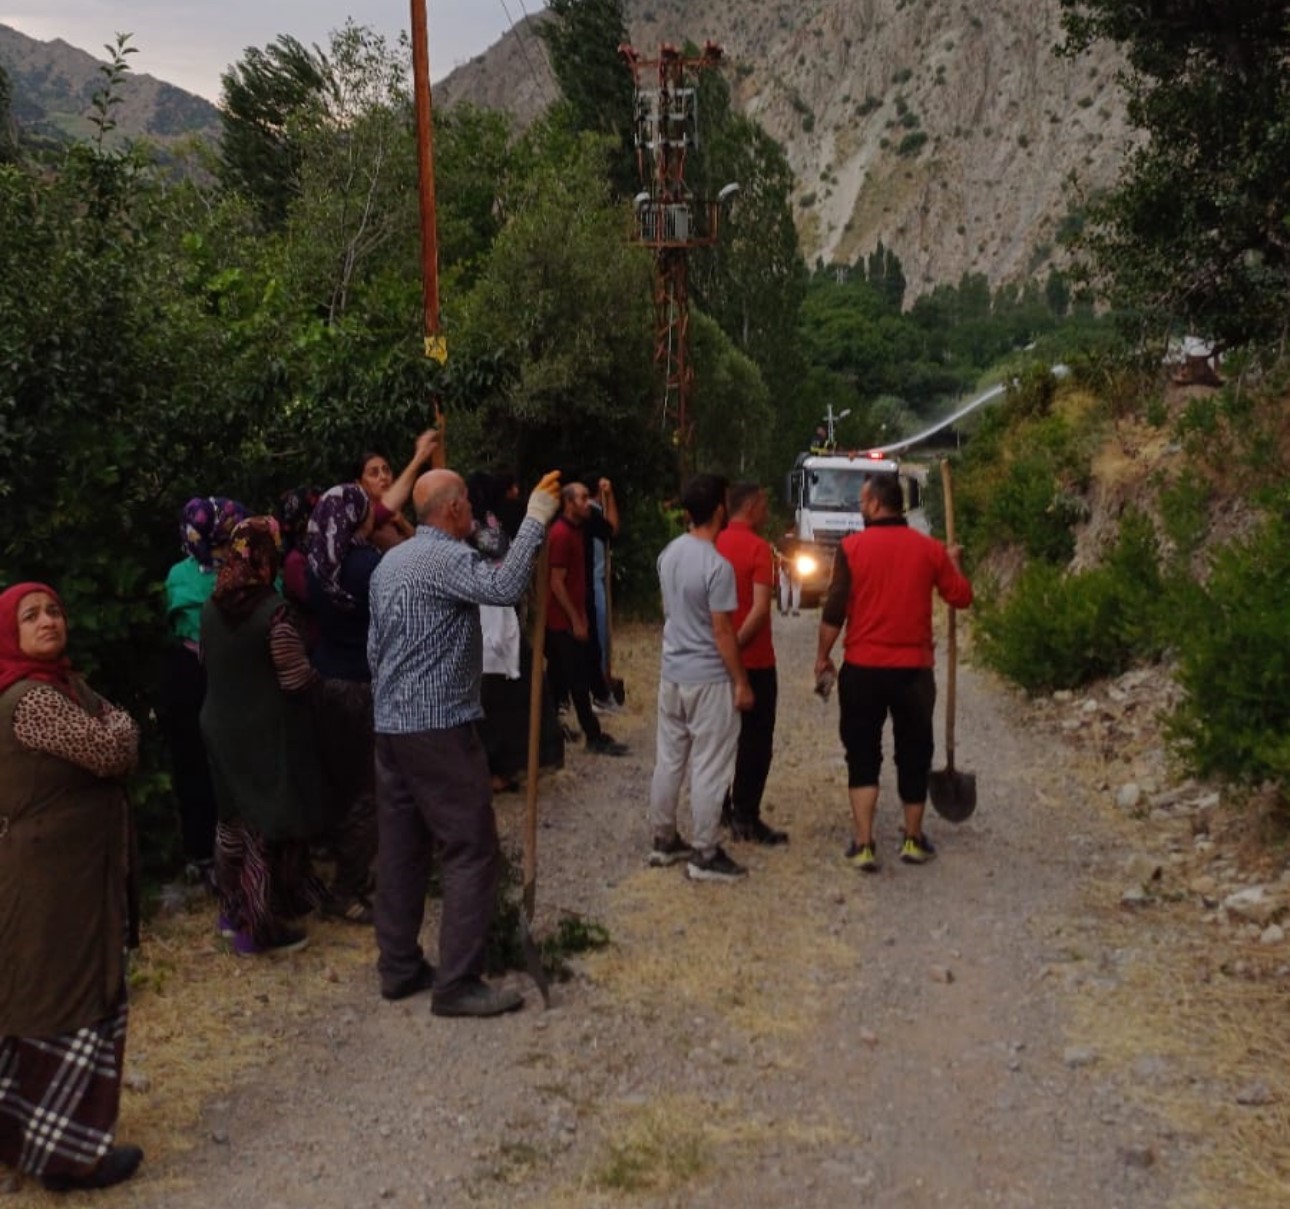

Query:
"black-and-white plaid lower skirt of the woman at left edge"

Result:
[[0, 990, 129, 1175]]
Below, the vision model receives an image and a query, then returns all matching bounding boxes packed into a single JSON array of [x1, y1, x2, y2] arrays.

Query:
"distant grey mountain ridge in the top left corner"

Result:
[[0, 25, 219, 145]]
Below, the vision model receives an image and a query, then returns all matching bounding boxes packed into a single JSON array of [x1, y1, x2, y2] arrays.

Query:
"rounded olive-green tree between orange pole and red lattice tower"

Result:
[[462, 123, 660, 486]]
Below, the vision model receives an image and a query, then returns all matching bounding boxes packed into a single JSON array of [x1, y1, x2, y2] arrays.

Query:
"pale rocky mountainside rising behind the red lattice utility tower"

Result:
[[435, 0, 1133, 294]]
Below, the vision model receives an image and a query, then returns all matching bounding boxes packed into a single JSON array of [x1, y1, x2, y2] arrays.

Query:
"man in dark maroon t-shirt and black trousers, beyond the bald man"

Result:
[[547, 483, 627, 756]]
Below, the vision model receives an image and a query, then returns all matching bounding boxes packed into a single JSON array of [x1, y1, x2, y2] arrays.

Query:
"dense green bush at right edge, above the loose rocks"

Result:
[[1170, 514, 1290, 783]]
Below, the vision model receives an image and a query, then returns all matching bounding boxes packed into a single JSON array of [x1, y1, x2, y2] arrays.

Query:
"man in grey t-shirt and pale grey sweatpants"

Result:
[[649, 475, 752, 881]]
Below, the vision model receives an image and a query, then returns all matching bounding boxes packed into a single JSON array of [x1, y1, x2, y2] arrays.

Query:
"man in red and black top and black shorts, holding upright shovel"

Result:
[[815, 474, 973, 874]]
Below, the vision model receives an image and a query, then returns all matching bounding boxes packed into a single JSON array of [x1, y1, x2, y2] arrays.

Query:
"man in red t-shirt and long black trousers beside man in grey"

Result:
[[716, 483, 788, 844]]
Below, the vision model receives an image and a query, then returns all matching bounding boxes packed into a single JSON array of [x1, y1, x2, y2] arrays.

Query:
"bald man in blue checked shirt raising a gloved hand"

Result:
[[368, 470, 560, 1017]]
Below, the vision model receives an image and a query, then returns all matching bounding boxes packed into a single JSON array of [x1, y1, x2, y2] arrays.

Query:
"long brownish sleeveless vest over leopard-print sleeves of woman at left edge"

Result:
[[0, 680, 129, 1037]]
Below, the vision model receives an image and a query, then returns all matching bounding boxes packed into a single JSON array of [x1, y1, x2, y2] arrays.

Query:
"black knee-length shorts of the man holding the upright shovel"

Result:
[[837, 663, 937, 805]]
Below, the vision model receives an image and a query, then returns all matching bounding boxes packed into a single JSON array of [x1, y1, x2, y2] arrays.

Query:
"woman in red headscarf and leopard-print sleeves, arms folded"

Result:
[[0, 583, 143, 1191]]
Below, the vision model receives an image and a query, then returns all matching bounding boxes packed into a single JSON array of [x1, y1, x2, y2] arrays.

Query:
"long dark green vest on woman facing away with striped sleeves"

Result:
[[201, 592, 329, 840]]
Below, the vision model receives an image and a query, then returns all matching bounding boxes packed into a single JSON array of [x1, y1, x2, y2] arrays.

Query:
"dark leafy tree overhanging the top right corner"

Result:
[[1062, 0, 1290, 345]]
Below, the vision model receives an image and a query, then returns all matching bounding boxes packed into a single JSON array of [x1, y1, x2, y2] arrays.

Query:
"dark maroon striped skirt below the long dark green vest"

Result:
[[215, 821, 326, 944]]
